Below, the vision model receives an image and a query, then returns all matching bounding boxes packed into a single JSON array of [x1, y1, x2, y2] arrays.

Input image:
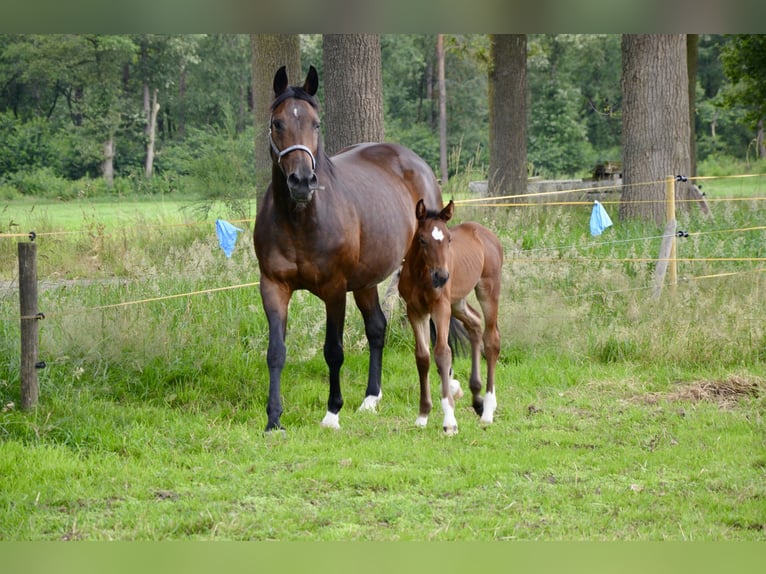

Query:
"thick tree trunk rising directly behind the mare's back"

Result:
[[322, 34, 384, 155]]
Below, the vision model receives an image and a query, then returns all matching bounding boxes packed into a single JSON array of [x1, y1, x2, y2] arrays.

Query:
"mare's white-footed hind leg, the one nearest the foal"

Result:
[[354, 287, 386, 411]]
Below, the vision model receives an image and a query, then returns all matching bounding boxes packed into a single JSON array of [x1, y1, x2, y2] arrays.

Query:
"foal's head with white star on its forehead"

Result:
[[413, 199, 455, 289]]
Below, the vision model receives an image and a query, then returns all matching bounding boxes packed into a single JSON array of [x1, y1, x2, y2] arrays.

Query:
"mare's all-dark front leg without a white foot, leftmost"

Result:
[[260, 278, 292, 432]]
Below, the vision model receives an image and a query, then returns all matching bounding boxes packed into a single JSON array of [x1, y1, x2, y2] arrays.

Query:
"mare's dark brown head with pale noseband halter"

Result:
[[269, 66, 321, 205]]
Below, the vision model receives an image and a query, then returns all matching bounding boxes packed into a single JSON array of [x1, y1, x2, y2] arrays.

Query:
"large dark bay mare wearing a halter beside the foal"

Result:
[[254, 66, 443, 431]]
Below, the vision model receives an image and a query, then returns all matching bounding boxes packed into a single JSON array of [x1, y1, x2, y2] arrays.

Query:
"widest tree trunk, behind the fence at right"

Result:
[[619, 34, 690, 225]]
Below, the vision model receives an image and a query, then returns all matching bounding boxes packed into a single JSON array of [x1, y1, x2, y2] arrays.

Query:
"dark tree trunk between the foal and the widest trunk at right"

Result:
[[488, 34, 528, 200]]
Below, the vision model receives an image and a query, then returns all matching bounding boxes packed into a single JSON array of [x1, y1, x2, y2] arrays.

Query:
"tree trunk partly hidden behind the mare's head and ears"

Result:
[[250, 34, 304, 205]]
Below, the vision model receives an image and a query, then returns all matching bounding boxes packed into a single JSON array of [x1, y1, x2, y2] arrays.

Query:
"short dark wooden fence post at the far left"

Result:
[[19, 242, 39, 409]]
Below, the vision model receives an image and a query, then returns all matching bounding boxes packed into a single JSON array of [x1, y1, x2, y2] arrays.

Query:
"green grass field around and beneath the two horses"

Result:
[[0, 180, 766, 541]]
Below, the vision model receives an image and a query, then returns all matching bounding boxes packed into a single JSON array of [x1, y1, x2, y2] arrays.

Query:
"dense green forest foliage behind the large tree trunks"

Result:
[[0, 34, 763, 199]]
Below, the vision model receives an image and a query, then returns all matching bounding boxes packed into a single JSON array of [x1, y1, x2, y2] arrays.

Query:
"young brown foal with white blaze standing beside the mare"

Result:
[[399, 201, 503, 434]]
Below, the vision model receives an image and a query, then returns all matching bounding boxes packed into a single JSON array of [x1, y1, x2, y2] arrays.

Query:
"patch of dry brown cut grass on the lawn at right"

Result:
[[641, 375, 766, 408]]
